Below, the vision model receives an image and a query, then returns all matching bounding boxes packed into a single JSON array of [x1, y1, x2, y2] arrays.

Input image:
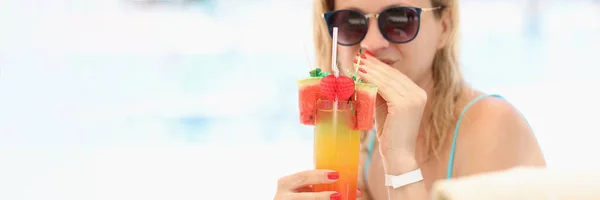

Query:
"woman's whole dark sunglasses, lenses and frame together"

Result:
[[323, 6, 442, 46]]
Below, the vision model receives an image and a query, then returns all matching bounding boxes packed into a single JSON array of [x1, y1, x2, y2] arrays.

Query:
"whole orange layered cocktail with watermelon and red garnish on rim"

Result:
[[299, 70, 377, 200]]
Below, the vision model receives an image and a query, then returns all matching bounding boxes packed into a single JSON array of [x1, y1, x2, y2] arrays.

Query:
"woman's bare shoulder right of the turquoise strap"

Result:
[[455, 94, 545, 176]]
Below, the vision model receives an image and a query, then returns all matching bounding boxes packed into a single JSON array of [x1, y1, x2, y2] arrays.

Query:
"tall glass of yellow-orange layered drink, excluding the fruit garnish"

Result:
[[313, 99, 361, 200]]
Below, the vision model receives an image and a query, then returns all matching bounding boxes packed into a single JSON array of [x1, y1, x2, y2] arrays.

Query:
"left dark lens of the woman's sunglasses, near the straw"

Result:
[[327, 10, 367, 45]]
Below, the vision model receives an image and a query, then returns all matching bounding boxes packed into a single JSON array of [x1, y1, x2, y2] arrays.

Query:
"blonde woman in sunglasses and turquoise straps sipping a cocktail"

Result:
[[275, 0, 545, 200]]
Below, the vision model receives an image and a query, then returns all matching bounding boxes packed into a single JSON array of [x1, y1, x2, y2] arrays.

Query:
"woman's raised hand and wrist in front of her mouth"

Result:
[[355, 51, 427, 158]]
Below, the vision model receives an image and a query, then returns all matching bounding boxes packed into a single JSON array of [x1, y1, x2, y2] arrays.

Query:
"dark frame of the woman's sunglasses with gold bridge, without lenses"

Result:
[[322, 6, 443, 46]]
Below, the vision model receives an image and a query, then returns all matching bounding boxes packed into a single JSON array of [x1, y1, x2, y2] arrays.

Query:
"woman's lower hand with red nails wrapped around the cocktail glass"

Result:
[[275, 170, 362, 200]]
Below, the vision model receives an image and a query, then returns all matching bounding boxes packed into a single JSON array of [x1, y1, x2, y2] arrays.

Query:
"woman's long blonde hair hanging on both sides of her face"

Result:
[[313, 0, 464, 158]]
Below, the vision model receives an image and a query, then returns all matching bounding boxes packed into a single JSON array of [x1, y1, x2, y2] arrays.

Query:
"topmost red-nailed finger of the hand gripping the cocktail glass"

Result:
[[278, 169, 340, 191]]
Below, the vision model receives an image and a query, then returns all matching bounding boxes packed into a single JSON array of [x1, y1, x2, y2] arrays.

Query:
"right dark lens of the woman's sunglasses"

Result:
[[379, 8, 419, 43]]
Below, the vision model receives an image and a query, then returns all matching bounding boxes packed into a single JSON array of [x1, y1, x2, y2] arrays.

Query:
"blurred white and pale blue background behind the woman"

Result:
[[0, 0, 600, 200]]
